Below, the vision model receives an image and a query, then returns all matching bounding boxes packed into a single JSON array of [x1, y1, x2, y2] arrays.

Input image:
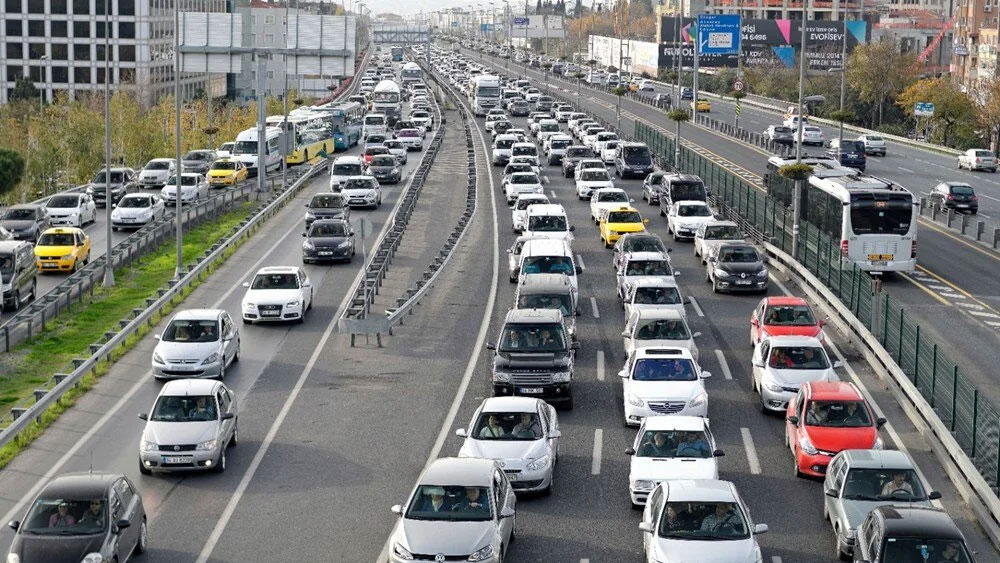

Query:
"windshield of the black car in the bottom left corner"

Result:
[[20, 497, 107, 536]]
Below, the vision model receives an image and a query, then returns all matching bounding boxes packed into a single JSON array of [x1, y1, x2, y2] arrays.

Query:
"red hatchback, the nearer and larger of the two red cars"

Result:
[[785, 381, 885, 477]]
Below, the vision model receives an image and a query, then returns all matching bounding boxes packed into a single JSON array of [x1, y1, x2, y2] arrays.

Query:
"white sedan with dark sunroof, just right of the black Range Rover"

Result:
[[618, 348, 712, 426]]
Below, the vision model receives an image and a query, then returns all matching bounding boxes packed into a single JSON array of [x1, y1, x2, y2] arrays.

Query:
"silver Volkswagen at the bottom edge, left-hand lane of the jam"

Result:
[[389, 457, 517, 563]]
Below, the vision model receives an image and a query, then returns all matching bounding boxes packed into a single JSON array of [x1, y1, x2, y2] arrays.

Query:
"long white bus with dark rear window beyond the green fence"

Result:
[[764, 156, 919, 273]]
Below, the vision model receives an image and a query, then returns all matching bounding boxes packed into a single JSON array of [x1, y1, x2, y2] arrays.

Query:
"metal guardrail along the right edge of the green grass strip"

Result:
[[0, 160, 329, 447]]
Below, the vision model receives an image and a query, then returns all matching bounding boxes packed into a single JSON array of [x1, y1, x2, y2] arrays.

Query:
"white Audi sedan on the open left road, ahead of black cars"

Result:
[[240, 266, 313, 324]]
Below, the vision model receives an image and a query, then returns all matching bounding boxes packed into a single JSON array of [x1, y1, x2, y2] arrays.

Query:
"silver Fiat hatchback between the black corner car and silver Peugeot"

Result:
[[139, 379, 239, 475]]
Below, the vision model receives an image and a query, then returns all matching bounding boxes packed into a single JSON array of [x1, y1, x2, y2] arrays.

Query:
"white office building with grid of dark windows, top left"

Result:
[[0, 0, 227, 105]]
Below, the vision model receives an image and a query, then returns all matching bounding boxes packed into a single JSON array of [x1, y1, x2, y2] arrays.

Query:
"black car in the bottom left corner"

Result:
[[7, 473, 149, 563]]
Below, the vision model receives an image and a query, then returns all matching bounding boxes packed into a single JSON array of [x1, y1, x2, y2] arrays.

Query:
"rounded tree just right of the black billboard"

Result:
[[847, 38, 917, 125]]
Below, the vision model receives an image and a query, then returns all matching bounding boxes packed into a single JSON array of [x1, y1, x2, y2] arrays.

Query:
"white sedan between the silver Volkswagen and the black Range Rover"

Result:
[[455, 397, 561, 494]]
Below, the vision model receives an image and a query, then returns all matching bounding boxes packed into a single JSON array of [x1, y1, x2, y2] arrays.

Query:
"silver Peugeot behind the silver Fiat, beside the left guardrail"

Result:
[[153, 309, 240, 380]]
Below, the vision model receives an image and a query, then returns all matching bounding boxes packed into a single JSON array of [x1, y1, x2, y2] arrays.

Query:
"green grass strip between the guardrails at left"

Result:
[[0, 203, 253, 469]]
